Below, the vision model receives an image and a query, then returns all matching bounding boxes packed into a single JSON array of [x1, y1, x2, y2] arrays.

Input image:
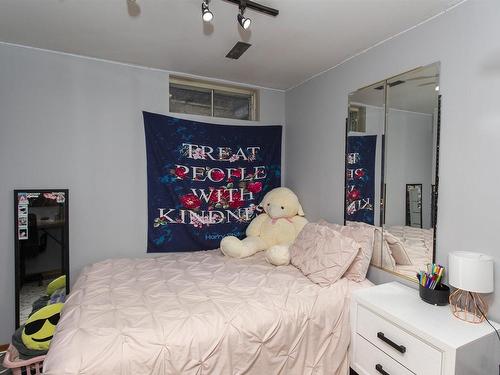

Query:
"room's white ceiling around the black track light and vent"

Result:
[[0, 0, 462, 89]]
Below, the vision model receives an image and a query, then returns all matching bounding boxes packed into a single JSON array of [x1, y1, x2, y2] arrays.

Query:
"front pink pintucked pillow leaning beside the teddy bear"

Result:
[[290, 223, 361, 286]]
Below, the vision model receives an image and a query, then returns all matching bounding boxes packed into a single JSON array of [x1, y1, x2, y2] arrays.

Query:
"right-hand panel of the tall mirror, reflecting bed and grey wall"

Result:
[[384, 64, 439, 278]]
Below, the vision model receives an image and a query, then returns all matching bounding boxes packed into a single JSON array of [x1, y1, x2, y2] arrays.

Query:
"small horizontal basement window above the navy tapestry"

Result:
[[170, 76, 258, 121]]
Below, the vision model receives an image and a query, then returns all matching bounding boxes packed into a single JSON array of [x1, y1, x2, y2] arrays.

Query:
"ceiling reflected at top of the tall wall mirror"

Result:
[[349, 64, 439, 114]]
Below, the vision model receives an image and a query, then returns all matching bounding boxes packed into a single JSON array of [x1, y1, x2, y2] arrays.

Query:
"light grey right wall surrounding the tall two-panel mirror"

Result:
[[286, 0, 500, 321]]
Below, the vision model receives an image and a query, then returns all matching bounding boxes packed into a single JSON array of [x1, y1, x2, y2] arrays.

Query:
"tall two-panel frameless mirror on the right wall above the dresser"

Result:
[[345, 63, 440, 281]]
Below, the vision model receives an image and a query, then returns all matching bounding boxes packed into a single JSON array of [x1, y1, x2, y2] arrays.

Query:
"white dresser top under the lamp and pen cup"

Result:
[[353, 282, 500, 348]]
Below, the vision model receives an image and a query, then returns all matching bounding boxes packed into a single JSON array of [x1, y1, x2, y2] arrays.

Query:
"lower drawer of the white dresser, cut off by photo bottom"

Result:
[[353, 335, 415, 375]]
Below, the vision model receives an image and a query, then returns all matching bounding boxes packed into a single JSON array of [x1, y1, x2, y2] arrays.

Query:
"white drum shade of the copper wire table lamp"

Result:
[[448, 251, 494, 293]]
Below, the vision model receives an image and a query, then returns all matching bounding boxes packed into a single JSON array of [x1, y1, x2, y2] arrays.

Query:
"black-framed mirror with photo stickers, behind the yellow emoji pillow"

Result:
[[14, 189, 69, 328]]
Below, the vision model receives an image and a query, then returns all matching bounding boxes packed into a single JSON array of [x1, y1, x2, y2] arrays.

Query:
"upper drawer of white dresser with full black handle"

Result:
[[356, 305, 442, 375]]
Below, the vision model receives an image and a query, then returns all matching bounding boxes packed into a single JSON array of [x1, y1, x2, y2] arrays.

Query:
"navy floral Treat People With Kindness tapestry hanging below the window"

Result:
[[143, 112, 282, 252]]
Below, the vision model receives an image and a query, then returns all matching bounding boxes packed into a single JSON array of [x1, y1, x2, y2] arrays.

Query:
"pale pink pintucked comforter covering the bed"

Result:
[[44, 250, 371, 375]]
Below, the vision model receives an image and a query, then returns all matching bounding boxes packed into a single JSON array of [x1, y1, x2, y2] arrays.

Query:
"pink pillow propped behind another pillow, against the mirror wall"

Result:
[[318, 220, 374, 282]]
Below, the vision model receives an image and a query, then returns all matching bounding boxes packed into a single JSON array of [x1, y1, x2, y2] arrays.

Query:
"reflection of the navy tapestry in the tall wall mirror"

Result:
[[346, 135, 377, 225]]
